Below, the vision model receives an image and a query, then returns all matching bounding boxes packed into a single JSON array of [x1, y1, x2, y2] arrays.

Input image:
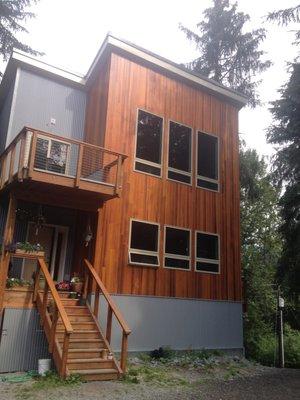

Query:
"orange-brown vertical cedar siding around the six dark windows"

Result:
[[86, 53, 241, 301]]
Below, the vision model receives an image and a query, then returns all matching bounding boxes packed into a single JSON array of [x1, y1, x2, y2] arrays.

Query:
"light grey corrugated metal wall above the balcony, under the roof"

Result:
[[6, 70, 86, 145]]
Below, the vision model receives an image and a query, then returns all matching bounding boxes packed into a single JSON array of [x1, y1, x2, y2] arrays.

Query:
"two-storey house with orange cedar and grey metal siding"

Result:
[[0, 35, 246, 379]]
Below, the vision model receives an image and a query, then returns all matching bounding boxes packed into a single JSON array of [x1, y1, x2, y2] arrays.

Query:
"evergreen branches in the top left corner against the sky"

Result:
[[0, 0, 42, 76]]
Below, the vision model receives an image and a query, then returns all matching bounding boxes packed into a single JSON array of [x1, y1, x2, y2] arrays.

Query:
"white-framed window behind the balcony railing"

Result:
[[34, 136, 70, 174]]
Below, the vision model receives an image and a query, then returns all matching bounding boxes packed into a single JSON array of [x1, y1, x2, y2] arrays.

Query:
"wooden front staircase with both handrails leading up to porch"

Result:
[[34, 258, 130, 380]]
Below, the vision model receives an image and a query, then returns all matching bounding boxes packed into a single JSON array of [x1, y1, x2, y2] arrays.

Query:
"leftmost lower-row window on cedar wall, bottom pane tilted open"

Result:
[[129, 220, 159, 267]]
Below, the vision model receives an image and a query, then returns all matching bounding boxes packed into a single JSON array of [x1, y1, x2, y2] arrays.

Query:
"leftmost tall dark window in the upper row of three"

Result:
[[135, 110, 163, 176]]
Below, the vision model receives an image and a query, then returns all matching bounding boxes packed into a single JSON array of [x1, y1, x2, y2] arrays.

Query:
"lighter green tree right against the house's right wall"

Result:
[[240, 144, 281, 359]]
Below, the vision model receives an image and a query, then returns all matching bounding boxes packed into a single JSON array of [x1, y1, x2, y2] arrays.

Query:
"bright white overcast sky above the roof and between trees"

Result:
[[5, 0, 299, 157]]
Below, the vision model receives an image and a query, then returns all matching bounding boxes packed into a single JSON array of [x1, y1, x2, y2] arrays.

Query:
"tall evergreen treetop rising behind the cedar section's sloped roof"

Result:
[[179, 0, 271, 107]]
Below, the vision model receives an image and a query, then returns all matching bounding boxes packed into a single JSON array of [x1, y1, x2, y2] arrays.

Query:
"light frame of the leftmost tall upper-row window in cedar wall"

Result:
[[133, 107, 165, 178]]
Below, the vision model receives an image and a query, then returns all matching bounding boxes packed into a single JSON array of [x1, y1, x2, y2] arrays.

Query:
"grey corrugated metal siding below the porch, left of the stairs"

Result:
[[0, 309, 51, 372]]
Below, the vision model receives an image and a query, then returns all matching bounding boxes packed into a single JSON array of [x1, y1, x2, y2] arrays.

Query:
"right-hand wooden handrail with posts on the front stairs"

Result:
[[83, 258, 131, 372]]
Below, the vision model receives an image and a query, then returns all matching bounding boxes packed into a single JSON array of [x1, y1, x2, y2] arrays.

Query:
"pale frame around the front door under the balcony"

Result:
[[21, 221, 69, 282]]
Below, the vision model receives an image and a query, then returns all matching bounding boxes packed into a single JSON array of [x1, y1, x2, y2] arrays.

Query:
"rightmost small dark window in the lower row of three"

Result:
[[195, 232, 220, 274]]
